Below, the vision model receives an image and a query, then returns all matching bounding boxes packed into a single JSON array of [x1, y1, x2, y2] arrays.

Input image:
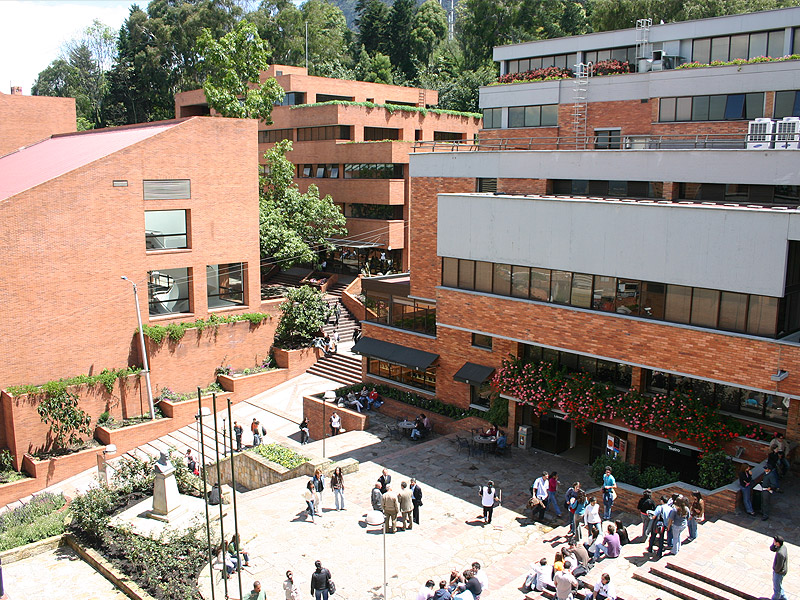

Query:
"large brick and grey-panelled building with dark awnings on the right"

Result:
[[360, 9, 800, 479]]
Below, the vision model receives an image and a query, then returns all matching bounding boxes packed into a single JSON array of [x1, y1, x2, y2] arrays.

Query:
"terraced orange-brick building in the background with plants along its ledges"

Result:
[[175, 65, 480, 273]]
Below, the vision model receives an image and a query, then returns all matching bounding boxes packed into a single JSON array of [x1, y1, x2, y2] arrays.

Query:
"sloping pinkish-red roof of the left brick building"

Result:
[[0, 121, 179, 201]]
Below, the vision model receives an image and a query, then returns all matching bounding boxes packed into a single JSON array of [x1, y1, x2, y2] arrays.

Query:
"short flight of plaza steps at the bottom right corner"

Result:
[[633, 562, 758, 600]]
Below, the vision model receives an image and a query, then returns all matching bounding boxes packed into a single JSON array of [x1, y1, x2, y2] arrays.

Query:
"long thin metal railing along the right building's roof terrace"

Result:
[[413, 133, 782, 152]]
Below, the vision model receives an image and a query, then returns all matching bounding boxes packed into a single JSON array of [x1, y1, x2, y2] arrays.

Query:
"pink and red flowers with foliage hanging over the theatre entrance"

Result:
[[493, 359, 756, 451]]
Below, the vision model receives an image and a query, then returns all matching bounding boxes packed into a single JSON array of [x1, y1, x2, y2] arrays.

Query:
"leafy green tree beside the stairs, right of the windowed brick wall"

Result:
[[260, 140, 347, 268]]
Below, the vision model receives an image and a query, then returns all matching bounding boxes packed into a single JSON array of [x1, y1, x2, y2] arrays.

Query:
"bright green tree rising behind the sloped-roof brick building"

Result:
[[198, 21, 284, 125]]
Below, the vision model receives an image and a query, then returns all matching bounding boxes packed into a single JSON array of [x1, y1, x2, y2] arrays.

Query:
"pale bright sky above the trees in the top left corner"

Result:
[[0, 0, 139, 94]]
